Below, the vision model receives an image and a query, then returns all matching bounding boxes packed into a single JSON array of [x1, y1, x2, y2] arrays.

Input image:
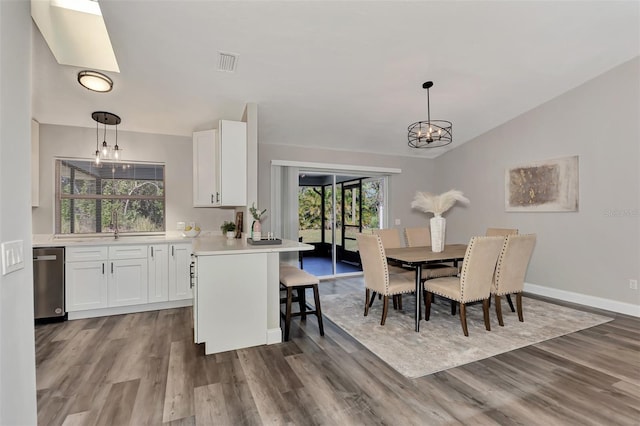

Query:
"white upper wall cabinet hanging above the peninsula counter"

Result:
[[193, 120, 247, 207]]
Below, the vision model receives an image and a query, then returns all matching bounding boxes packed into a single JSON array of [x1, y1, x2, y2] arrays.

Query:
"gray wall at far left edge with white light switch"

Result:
[[0, 1, 37, 425]]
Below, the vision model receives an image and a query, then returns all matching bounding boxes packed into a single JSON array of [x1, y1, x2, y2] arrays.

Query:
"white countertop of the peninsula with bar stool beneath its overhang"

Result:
[[193, 236, 313, 256]]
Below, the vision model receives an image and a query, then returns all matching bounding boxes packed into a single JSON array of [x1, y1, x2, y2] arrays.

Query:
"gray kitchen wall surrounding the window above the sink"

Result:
[[33, 123, 235, 234]]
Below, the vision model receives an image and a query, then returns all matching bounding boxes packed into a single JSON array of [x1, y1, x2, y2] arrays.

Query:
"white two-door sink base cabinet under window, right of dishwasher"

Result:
[[65, 245, 148, 312]]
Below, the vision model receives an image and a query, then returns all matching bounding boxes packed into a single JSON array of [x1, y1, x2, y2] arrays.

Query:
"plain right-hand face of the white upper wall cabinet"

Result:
[[221, 120, 247, 206]]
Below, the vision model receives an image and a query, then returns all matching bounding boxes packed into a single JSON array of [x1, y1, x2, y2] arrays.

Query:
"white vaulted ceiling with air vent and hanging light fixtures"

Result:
[[33, 0, 640, 158]]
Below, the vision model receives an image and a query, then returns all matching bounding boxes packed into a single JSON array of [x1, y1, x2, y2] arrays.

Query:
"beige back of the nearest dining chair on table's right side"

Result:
[[460, 236, 505, 303]]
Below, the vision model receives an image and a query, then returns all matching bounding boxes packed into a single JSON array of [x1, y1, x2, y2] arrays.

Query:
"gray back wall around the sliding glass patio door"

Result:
[[258, 144, 435, 233]]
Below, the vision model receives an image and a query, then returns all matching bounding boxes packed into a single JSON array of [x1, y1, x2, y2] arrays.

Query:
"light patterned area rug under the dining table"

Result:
[[321, 292, 612, 378]]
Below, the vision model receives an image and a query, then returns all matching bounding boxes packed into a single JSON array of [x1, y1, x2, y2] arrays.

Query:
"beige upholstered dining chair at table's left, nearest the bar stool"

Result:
[[356, 234, 415, 325]]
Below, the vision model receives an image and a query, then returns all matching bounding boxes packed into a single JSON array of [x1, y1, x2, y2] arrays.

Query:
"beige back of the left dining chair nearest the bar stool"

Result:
[[356, 234, 389, 294]]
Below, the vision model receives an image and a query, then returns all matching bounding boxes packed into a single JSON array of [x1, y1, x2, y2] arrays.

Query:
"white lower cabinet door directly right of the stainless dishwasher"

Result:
[[65, 261, 107, 312]]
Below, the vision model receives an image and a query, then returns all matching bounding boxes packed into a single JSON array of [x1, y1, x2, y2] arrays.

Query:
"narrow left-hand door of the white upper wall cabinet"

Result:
[[193, 130, 220, 207]]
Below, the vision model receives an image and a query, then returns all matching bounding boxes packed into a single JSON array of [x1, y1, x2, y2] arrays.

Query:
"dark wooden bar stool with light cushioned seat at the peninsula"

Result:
[[280, 264, 324, 342]]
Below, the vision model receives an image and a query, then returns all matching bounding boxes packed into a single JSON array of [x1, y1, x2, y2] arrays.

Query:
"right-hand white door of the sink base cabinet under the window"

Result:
[[107, 259, 148, 307]]
